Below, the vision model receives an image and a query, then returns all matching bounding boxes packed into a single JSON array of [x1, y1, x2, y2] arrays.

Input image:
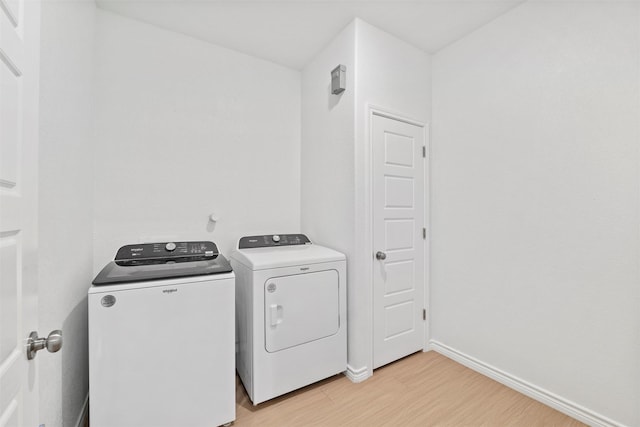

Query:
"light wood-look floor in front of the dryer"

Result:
[[234, 351, 584, 427]]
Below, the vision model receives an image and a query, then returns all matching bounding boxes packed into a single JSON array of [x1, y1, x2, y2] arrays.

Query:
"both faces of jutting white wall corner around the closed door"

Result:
[[301, 19, 430, 380]]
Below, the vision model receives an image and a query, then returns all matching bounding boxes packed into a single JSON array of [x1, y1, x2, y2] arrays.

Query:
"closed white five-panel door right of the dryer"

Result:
[[371, 115, 425, 369]]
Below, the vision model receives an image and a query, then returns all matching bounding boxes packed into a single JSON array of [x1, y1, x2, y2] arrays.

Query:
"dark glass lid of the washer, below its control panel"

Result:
[[93, 255, 233, 285]]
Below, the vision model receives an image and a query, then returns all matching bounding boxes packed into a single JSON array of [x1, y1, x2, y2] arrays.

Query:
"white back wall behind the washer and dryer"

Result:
[[94, 11, 300, 272]]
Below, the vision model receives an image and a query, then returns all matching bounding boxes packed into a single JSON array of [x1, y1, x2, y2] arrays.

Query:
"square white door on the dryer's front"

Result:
[[264, 270, 340, 353]]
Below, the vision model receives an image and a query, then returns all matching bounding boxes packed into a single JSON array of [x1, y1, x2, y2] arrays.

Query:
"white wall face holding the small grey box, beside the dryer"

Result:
[[301, 18, 356, 370]]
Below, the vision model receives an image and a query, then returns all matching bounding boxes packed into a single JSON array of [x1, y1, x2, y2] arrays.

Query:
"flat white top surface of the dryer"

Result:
[[231, 244, 346, 270]]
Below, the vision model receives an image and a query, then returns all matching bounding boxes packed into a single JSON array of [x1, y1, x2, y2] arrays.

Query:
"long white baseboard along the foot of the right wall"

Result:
[[429, 340, 624, 427]]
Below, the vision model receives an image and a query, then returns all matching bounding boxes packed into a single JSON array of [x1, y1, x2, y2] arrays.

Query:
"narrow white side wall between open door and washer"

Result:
[[36, 1, 95, 427]]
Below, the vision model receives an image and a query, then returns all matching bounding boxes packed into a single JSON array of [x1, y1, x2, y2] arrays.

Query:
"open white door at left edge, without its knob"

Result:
[[0, 0, 40, 427]]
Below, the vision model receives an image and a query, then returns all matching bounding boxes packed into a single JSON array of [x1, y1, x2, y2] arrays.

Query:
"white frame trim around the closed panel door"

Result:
[[363, 104, 431, 376]]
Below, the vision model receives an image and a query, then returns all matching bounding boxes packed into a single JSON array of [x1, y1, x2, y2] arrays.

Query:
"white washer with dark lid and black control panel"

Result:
[[88, 242, 235, 427]]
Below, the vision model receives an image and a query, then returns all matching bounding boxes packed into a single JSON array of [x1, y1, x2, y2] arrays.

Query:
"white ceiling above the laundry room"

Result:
[[97, 0, 524, 69]]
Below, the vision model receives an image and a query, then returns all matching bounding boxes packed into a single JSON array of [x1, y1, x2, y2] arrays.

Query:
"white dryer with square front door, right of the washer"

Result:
[[230, 234, 347, 405]]
